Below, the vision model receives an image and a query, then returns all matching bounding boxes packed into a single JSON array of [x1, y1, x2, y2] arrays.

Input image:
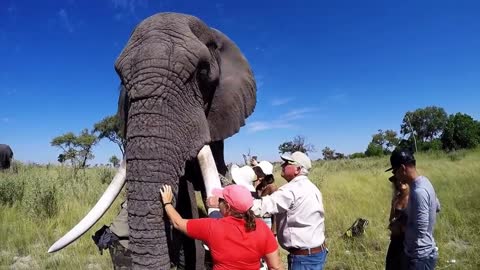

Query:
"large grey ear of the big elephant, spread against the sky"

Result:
[[207, 29, 256, 141]]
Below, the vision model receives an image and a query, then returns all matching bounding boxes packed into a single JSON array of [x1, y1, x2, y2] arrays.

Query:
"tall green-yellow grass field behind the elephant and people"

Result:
[[0, 150, 480, 269]]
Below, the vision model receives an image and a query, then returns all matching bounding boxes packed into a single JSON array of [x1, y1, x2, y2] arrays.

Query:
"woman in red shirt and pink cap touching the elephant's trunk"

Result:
[[160, 185, 284, 270]]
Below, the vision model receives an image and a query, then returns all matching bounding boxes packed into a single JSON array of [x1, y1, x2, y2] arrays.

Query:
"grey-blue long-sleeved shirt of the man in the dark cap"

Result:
[[405, 176, 440, 258]]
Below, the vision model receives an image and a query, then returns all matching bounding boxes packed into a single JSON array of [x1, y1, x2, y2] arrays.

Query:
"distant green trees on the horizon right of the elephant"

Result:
[[278, 106, 480, 160]]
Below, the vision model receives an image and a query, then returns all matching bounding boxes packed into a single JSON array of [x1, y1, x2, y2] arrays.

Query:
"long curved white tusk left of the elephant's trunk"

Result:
[[48, 160, 127, 253]]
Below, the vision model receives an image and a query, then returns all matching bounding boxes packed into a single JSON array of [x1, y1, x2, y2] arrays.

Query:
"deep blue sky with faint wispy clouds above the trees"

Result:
[[0, 0, 480, 163]]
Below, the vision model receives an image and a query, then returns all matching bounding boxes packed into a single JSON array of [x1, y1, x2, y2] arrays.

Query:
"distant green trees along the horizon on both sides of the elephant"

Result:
[[50, 106, 480, 168]]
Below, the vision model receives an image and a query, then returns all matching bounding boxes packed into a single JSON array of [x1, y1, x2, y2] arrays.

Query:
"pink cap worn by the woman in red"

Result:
[[212, 185, 253, 213]]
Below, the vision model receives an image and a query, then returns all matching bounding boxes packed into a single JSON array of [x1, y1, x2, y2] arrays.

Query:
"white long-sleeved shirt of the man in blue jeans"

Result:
[[252, 176, 325, 250]]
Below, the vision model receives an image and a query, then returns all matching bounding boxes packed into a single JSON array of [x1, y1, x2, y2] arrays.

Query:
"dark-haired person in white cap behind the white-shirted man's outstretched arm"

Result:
[[253, 160, 278, 233]]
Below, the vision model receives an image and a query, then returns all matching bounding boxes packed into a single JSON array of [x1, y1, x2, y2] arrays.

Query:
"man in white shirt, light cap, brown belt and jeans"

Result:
[[252, 152, 328, 270]]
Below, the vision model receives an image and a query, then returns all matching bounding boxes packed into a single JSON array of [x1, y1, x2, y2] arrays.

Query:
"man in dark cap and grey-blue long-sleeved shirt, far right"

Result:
[[387, 149, 440, 270]]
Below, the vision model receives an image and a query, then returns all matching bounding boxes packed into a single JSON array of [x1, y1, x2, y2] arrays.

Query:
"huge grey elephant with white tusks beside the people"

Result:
[[49, 13, 256, 269]]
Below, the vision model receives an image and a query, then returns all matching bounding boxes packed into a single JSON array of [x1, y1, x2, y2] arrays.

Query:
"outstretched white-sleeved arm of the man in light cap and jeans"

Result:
[[252, 187, 295, 216]]
